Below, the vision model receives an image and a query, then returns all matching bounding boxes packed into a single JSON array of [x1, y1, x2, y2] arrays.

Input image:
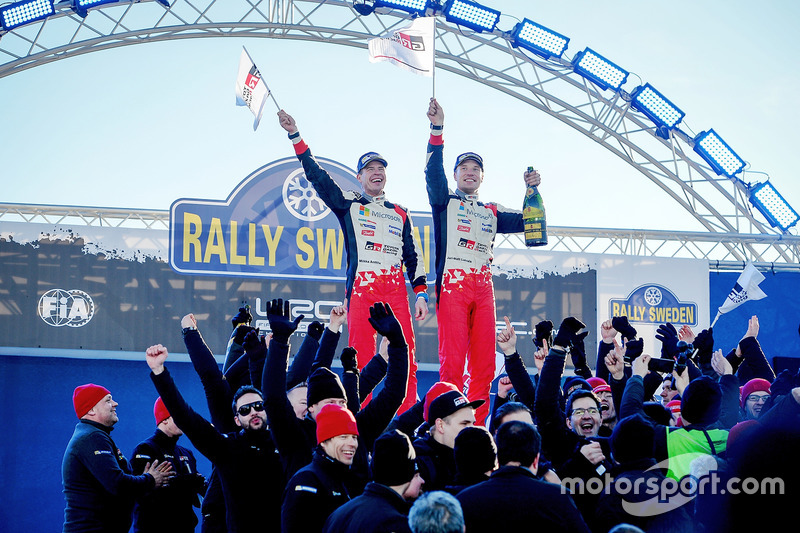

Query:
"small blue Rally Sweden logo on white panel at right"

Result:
[[609, 283, 698, 326]]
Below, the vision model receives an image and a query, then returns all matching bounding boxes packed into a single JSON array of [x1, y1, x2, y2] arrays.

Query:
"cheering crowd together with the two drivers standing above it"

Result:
[[62, 100, 800, 533]]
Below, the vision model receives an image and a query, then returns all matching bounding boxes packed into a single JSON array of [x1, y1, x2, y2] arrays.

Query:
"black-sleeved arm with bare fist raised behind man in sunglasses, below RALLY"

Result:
[[183, 313, 236, 431]]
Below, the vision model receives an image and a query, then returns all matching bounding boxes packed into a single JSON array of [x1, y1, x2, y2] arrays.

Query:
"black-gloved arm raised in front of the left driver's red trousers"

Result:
[[355, 302, 408, 450]]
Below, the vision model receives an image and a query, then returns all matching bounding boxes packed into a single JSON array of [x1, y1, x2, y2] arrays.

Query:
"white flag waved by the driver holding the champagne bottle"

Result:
[[369, 17, 435, 77]]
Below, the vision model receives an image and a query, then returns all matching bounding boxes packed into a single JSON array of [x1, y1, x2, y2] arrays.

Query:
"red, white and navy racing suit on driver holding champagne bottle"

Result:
[[425, 130, 523, 424]]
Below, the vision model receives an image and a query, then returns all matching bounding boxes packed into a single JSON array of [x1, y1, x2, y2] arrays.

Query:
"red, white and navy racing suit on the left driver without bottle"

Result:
[[293, 137, 428, 413]]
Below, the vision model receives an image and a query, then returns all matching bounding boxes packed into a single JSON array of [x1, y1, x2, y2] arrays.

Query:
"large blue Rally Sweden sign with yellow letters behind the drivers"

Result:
[[170, 157, 432, 281]]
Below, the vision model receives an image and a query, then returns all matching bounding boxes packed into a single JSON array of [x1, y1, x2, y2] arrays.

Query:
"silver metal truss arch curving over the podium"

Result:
[[0, 0, 798, 262]]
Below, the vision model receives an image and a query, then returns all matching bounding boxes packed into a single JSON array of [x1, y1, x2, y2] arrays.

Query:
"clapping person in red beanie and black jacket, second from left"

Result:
[[131, 398, 206, 533]]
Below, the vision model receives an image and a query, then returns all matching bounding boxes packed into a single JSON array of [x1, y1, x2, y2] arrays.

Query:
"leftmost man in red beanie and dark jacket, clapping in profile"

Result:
[[61, 383, 173, 533]]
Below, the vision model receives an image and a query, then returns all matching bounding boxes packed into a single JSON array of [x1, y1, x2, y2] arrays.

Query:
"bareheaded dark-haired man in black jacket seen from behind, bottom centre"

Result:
[[456, 421, 589, 533]]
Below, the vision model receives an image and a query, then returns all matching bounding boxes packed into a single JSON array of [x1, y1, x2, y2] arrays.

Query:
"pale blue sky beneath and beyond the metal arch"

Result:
[[0, 0, 800, 231]]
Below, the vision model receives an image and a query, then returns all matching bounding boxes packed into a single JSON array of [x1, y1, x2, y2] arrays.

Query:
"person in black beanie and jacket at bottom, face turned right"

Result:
[[323, 430, 422, 533]]
